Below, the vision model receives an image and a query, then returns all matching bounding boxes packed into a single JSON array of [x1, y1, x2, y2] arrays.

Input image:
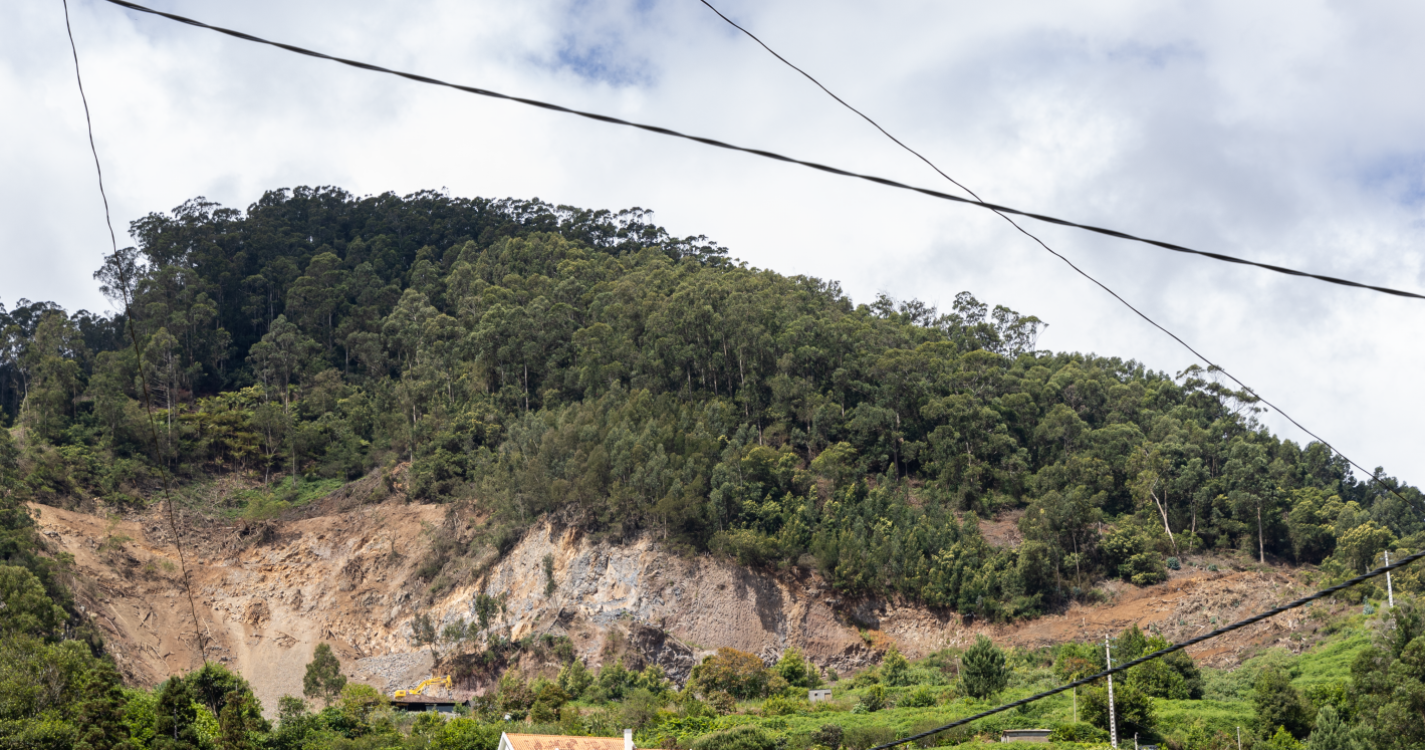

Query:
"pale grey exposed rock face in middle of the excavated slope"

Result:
[[461, 526, 940, 677]]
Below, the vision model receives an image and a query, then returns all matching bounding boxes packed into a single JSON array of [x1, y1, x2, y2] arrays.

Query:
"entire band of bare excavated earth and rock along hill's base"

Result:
[[33, 496, 1317, 721]]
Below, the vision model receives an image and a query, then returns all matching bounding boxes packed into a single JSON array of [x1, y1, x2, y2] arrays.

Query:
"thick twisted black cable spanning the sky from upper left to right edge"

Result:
[[94, 0, 1425, 299]]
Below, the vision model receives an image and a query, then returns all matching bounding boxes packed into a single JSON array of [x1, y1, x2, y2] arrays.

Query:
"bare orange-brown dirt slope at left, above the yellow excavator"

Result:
[[34, 503, 445, 721]]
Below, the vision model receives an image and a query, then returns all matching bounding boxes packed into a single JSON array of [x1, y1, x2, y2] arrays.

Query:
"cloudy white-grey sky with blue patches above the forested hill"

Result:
[[0, 0, 1425, 483]]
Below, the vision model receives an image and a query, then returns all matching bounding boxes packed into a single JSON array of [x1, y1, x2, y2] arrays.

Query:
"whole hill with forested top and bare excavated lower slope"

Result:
[[0, 188, 1425, 744]]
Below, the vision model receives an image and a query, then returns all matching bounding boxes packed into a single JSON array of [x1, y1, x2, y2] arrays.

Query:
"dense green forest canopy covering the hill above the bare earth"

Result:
[[0, 188, 1425, 619]]
